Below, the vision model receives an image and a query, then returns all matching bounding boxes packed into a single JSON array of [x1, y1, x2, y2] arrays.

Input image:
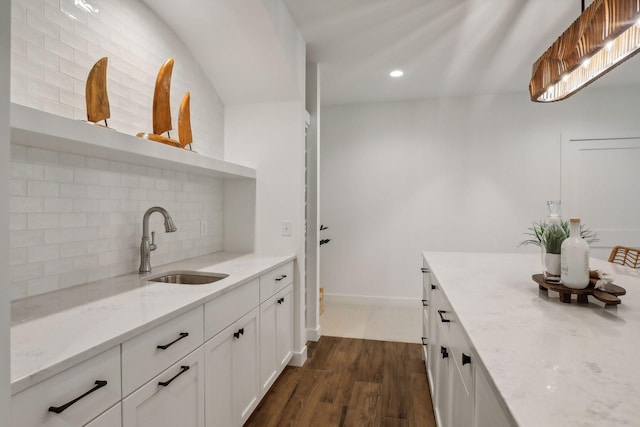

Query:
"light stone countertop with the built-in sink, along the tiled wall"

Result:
[[11, 252, 295, 394]]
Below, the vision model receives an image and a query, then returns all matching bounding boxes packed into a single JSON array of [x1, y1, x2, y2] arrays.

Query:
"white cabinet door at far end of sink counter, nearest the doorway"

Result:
[[260, 285, 293, 395]]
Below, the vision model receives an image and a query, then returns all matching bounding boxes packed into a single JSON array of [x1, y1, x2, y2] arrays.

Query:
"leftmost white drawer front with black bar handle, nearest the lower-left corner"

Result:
[[11, 346, 121, 427]]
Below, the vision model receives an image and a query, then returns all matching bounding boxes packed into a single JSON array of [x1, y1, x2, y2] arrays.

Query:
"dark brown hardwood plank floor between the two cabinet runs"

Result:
[[245, 337, 436, 427]]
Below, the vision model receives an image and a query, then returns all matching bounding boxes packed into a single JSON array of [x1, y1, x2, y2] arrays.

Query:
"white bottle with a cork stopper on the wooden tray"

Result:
[[560, 218, 589, 289]]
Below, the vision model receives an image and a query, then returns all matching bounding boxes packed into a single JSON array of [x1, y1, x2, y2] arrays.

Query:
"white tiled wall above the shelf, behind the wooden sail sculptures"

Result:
[[11, 0, 224, 158]]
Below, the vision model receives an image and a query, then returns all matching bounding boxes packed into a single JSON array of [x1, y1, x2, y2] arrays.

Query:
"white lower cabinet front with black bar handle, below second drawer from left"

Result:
[[122, 347, 204, 427]]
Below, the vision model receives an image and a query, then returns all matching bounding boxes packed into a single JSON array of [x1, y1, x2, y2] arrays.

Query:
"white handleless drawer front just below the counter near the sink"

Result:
[[204, 279, 260, 340]]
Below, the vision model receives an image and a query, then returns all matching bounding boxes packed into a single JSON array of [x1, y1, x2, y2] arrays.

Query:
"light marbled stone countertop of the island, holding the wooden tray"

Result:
[[423, 252, 640, 427]]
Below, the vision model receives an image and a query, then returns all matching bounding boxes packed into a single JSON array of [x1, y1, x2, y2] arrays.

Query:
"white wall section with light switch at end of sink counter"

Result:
[[224, 101, 306, 361]]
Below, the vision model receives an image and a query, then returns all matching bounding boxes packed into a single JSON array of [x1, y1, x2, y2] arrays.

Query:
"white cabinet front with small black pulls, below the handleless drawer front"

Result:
[[202, 308, 260, 427]]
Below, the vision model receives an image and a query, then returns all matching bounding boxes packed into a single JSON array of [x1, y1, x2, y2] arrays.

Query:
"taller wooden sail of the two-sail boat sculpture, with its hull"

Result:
[[138, 58, 182, 147]]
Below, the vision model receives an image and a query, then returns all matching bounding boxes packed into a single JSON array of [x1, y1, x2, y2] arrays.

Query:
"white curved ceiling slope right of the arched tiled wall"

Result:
[[143, 0, 305, 105]]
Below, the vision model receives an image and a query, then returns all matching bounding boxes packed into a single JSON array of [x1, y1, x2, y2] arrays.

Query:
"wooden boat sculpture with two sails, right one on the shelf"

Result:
[[137, 58, 192, 148]]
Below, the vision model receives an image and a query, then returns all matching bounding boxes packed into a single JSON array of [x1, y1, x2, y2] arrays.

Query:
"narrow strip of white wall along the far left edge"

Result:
[[0, 1, 11, 426]]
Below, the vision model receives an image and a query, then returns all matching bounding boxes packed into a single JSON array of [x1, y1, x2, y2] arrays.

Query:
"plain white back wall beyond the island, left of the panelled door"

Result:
[[321, 87, 640, 299]]
